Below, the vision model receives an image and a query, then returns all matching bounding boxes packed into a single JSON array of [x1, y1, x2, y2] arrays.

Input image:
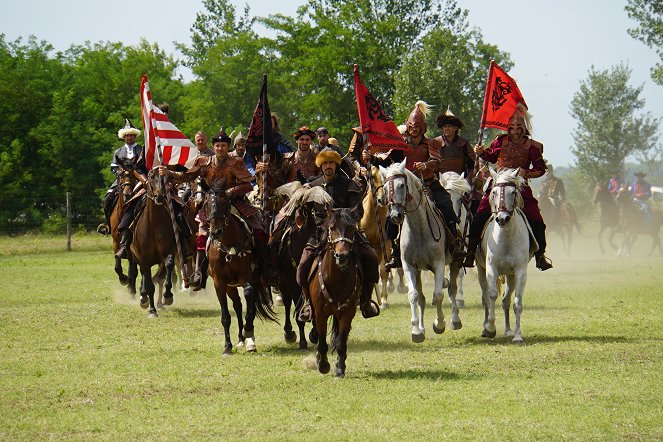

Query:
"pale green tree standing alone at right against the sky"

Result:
[[571, 64, 660, 180]]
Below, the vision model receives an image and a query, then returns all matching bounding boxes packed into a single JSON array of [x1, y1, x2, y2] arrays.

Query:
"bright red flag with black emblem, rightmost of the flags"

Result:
[[481, 61, 527, 130]]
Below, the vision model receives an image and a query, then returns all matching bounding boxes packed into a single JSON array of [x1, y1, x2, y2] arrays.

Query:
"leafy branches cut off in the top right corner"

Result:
[[625, 0, 663, 85]]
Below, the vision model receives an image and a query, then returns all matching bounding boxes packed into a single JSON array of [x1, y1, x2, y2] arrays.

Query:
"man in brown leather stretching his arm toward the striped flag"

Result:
[[159, 129, 278, 287]]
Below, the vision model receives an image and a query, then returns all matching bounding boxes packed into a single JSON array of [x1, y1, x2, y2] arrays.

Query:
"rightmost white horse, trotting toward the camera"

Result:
[[476, 169, 531, 343]]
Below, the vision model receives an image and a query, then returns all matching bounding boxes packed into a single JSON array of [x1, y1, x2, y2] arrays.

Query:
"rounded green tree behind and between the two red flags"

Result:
[[394, 28, 512, 142]]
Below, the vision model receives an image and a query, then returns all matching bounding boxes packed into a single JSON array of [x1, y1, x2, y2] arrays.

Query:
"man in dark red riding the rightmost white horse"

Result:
[[463, 107, 552, 271]]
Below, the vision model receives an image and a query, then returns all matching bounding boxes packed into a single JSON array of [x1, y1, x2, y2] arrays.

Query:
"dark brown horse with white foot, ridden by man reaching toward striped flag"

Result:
[[205, 179, 276, 355]]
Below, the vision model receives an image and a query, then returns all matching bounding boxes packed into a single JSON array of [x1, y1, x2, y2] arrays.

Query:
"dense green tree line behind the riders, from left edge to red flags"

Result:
[[0, 0, 653, 230]]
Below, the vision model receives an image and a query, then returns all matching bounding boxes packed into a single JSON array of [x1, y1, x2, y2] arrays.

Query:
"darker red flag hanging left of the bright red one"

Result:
[[354, 65, 408, 150]]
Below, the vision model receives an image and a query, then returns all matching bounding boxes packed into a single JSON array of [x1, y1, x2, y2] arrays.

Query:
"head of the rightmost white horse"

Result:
[[489, 169, 525, 227]]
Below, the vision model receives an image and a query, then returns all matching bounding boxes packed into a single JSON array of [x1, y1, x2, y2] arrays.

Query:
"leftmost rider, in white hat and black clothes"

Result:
[[103, 118, 147, 230]]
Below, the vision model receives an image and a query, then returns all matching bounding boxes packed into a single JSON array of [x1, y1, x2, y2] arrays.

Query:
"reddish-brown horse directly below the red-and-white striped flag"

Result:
[[130, 170, 176, 318]]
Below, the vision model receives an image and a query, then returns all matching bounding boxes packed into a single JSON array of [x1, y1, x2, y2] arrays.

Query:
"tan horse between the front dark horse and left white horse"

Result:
[[359, 166, 407, 309]]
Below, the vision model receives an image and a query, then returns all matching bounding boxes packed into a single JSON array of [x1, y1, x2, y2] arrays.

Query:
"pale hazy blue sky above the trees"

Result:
[[0, 0, 663, 166]]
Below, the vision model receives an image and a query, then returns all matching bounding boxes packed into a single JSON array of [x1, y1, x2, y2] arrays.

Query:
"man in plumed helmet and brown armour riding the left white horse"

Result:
[[385, 101, 465, 269]]
